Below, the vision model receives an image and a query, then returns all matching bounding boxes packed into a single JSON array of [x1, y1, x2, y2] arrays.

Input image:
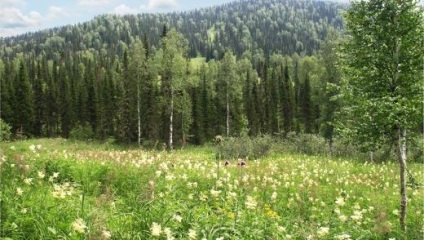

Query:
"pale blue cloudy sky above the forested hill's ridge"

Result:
[[0, 0, 232, 37]]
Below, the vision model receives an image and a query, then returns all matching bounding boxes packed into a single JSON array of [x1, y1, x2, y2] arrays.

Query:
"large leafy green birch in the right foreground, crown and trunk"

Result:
[[342, 0, 424, 231]]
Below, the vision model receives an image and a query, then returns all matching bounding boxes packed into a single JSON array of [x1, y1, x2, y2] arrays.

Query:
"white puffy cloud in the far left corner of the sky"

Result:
[[0, 8, 43, 28]]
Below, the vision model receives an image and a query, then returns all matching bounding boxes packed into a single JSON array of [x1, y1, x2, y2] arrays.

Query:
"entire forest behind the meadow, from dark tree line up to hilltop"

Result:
[[0, 0, 346, 148]]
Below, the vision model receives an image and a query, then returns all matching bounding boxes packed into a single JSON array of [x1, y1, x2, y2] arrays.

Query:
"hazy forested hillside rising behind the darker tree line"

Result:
[[0, 0, 345, 60]]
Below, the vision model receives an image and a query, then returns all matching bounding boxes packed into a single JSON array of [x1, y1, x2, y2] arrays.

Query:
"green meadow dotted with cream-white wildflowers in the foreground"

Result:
[[0, 139, 424, 240]]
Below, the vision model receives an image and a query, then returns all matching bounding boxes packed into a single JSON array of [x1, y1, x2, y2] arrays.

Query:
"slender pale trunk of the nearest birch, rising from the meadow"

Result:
[[398, 129, 407, 231]]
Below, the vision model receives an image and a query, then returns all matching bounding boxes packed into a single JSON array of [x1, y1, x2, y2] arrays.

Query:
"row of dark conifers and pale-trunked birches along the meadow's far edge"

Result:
[[0, 27, 338, 148]]
